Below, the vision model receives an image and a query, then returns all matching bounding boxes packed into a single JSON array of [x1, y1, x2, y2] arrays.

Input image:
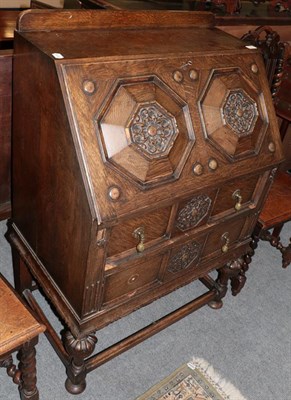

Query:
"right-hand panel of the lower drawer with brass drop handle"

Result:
[[201, 217, 246, 259]]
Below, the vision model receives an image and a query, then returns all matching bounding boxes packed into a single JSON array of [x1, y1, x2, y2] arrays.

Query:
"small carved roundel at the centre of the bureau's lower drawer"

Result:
[[167, 241, 201, 273]]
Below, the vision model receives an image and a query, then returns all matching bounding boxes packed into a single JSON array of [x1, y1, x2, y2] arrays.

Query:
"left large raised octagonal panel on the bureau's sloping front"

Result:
[[95, 76, 195, 188]]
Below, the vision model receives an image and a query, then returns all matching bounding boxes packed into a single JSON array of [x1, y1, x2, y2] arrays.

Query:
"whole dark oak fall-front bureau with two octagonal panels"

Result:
[[8, 10, 282, 393]]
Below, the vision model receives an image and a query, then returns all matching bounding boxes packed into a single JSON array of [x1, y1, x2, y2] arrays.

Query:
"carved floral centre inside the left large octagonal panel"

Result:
[[128, 102, 178, 157]]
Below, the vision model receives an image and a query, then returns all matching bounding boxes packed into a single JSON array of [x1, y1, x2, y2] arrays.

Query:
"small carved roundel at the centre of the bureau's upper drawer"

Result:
[[176, 194, 211, 231]]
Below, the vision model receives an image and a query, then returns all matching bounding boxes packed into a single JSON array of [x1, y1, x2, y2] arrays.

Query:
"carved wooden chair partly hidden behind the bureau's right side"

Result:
[[242, 26, 291, 268]]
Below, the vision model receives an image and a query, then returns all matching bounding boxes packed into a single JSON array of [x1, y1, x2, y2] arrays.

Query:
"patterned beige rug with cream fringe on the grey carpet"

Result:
[[136, 359, 247, 400]]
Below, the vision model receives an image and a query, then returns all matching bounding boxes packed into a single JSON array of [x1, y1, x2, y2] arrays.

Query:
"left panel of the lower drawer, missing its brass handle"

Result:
[[103, 254, 163, 306]]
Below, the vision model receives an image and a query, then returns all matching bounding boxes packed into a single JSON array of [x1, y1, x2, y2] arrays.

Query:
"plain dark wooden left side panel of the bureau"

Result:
[[12, 35, 96, 313]]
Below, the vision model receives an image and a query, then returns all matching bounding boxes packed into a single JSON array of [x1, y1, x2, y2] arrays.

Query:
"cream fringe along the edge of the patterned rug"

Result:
[[187, 358, 247, 400]]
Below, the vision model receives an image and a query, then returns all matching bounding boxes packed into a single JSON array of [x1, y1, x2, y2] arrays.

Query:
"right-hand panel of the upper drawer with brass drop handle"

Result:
[[211, 175, 260, 217]]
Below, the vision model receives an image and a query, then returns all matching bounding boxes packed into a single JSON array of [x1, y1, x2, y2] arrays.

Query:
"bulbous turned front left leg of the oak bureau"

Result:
[[64, 331, 97, 394]]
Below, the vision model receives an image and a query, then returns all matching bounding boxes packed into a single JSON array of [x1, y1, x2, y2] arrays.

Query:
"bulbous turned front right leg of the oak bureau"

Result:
[[208, 259, 245, 309]]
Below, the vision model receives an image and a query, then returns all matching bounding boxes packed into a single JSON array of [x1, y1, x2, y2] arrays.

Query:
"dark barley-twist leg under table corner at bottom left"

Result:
[[19, 338, 39, 400]]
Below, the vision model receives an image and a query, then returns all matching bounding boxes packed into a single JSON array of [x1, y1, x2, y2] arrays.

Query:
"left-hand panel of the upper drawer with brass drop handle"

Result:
[[107, 207, 171, 257]]
